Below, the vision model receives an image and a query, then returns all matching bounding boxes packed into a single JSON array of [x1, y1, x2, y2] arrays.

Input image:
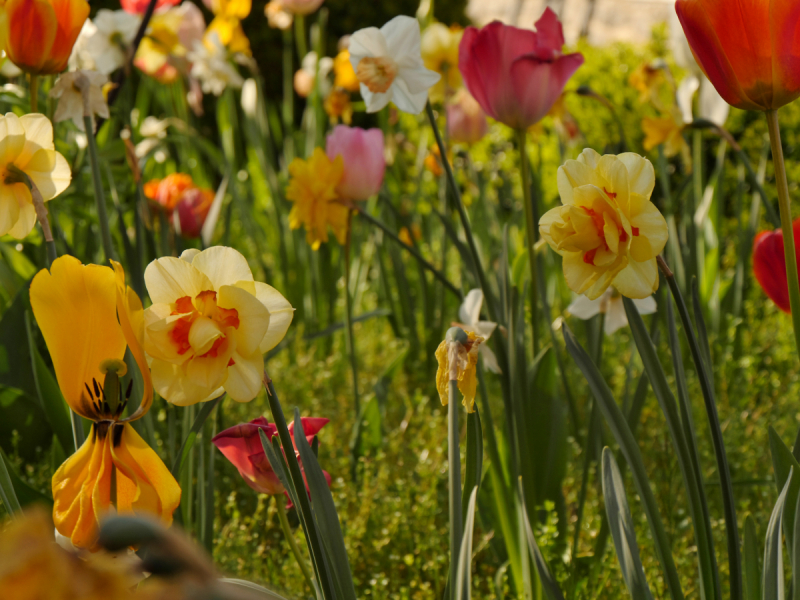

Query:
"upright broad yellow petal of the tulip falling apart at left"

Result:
[[30, 256, 127, 419]]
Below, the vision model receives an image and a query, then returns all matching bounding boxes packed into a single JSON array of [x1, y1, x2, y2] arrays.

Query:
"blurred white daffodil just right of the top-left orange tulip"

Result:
[[70, 8, 142, 75]]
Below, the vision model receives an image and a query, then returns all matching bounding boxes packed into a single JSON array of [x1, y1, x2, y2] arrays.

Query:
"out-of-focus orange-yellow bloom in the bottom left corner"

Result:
[[0, 508, 139, 600]]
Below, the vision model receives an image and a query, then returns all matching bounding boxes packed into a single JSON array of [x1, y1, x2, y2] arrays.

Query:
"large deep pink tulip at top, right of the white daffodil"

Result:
[[458, 8, 583, 129]]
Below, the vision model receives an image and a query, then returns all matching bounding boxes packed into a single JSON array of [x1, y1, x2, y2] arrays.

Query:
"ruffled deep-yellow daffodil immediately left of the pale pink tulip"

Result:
[[286, 148, 347, 250]]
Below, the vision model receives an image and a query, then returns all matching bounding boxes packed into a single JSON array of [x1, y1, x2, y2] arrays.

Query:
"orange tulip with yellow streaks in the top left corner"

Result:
[[5, 0, 89, 75]]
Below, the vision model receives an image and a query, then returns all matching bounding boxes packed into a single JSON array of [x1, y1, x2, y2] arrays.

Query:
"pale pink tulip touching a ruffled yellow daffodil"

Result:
[[325, 125, 386, 200]]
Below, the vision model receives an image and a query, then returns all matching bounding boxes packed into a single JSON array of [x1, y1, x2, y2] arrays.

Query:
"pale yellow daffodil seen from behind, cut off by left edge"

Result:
[[0, 113, 72, 239]]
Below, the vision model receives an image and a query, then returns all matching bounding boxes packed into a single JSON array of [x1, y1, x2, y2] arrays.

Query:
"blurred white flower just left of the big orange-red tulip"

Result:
[[669, 11, 731, 127]]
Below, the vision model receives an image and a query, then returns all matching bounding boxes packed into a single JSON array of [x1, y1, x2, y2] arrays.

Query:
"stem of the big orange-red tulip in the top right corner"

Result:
[[765, 110, 800, 352]]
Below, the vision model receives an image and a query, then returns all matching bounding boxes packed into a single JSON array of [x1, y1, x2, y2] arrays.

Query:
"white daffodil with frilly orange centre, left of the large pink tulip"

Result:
[[350, 16, 440, 115]]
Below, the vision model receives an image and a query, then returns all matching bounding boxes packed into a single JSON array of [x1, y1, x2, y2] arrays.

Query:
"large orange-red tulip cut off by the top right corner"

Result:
[[675, 0, 800, 110]]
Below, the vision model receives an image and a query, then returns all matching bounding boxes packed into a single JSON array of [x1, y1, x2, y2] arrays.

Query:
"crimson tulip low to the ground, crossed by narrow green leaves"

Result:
[[211, 417, 331, 506]]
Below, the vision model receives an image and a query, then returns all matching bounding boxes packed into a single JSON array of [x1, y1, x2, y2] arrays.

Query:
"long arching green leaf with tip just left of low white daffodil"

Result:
[[562, 324, 684, 600]]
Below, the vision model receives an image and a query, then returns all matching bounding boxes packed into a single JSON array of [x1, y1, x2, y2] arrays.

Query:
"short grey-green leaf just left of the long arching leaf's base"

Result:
[[603, 448, 653, 600]]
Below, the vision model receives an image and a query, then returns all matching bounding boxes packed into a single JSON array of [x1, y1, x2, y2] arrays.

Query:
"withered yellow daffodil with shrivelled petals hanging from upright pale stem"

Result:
[[436, 328, 484, 412]]
